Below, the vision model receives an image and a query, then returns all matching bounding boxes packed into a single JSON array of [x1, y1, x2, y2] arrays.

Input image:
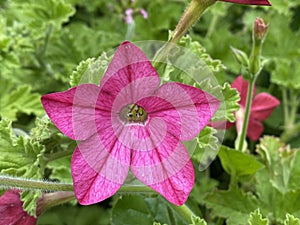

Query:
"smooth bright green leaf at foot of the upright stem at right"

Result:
[[219, 146, 263, 178]]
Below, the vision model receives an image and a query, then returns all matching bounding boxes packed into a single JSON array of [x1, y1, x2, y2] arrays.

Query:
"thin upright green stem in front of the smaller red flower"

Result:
[[238, 78, 255, 151]]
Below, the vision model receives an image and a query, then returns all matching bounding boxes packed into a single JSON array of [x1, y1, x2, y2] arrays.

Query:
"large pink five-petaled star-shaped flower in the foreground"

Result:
[[42, 42, 219, 205]]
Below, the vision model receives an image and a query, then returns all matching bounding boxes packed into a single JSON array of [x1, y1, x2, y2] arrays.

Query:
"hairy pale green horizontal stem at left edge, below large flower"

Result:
[[0, 175, 73, 191]]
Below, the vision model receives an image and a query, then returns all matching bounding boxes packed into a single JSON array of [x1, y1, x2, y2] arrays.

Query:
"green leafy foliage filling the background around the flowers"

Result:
[[0, 0, 300, 225]]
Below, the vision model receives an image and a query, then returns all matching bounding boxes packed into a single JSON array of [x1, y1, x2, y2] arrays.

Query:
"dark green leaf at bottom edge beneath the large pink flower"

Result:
[[112, 195, 185, 225]]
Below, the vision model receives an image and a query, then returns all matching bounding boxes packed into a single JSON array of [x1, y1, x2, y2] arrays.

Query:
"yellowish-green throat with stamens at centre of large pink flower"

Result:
[[120, 104, 148, 123]]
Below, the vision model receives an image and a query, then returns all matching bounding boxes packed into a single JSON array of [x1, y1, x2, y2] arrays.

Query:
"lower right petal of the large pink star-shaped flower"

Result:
[[131, 142, 195, 205]]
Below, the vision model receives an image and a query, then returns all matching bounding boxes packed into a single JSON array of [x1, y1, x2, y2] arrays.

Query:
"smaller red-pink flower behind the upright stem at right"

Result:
[[231, 76, 280, 141]]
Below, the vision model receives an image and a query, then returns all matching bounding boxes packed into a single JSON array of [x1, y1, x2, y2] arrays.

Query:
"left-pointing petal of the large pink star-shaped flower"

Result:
[[41, 84, 103, 140]]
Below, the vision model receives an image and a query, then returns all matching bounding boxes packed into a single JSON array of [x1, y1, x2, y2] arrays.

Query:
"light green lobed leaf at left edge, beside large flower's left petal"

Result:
[[0, 79, 44, 120]]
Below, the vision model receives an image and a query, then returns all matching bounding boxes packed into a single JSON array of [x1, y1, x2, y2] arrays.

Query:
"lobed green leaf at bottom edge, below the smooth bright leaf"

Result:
[[204, 189, 259, 225]]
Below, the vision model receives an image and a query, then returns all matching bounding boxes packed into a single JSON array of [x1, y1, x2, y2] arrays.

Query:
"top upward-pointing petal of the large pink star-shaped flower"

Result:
[[100, 41, 160, 91]]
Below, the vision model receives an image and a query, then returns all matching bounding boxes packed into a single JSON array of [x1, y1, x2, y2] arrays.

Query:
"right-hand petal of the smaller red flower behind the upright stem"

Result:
[[250, 93, 280, 121]]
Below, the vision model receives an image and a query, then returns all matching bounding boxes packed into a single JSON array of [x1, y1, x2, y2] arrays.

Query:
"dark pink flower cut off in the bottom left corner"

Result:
[[0, 190, 37, 225]]
